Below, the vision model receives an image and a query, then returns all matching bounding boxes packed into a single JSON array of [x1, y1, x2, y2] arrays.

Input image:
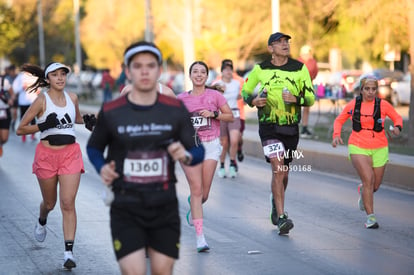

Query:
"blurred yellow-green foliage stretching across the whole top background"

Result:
[[0, 0, 409, 74]]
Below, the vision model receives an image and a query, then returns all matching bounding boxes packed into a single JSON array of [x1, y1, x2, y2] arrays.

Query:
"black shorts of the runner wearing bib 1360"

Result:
[[110, 199, 181, 260]]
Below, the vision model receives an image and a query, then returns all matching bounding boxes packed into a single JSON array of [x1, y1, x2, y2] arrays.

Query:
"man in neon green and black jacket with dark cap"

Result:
[[242, 32, 315, 235]]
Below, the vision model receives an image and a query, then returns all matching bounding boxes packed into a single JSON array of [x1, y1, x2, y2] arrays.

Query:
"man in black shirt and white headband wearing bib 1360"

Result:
[[87, 42, 204, 274]]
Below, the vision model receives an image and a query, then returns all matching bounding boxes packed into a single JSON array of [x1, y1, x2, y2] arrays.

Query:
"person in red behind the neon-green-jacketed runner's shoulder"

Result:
[[298, 45, 318, 138]]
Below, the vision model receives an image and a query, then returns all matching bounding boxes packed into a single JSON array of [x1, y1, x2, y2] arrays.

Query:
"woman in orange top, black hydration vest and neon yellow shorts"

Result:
[[332, 76, 403, 228]]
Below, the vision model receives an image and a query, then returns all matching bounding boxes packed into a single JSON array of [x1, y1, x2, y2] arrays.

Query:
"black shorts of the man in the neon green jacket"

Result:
[[259, 123, 299, 165]]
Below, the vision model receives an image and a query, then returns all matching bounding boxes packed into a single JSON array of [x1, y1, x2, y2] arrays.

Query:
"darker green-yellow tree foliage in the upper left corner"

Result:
[[0, 0, 78, 67]]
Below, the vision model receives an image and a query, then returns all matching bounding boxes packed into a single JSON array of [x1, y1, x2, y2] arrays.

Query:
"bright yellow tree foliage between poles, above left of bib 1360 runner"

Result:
[[81, 0, 145, 75]]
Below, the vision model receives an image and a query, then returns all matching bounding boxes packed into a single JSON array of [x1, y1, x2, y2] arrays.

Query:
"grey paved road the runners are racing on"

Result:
[[0, 128, 414, 275]]
